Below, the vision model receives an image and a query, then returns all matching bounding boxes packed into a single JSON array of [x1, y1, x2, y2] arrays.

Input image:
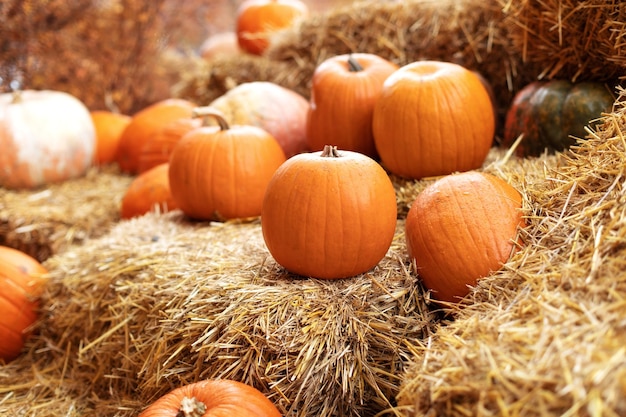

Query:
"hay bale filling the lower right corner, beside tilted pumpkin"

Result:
[[399, 90, 626, 416]]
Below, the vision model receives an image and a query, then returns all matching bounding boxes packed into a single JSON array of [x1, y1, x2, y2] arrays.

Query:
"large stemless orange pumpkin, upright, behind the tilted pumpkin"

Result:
[[373, 61, 495, 179]]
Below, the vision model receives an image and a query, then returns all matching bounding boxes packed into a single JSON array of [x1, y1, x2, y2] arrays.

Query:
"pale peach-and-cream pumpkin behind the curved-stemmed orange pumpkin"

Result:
[[209, 81, 309, 158]]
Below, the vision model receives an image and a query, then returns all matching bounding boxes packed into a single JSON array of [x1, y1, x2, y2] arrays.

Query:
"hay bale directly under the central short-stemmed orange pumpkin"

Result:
[[0, 212, 435, 416]]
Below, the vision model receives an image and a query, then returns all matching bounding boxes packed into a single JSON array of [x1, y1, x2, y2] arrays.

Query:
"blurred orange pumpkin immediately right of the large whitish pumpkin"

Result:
[[90, 110, 131, 165]]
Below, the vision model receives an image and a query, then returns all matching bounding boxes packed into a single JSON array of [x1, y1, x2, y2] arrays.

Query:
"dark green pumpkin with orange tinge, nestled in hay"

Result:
[[503, 80, 615, 156]]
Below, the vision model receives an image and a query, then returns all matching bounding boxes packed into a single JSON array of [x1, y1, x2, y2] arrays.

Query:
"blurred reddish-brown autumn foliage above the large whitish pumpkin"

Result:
[[0, 0, 349, 114]]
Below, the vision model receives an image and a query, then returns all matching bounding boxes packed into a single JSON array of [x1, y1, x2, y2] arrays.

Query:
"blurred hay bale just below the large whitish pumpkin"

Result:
[[0, 166, 131, 262]]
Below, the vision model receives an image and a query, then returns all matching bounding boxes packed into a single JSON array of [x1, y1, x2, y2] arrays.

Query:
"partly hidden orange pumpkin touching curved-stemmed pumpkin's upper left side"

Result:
[[137, 117, 202, 174]]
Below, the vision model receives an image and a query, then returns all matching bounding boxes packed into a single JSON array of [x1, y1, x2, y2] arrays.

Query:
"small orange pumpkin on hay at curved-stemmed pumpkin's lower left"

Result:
[[121, 162, 177, 219]]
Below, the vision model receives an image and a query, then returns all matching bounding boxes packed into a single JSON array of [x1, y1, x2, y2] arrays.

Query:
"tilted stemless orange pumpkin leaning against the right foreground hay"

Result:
[[405, 171, 525, 302]]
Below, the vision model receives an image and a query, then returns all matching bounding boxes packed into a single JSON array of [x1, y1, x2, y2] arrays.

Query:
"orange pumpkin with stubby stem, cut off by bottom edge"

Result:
[[139, 379, 281, 417]]
